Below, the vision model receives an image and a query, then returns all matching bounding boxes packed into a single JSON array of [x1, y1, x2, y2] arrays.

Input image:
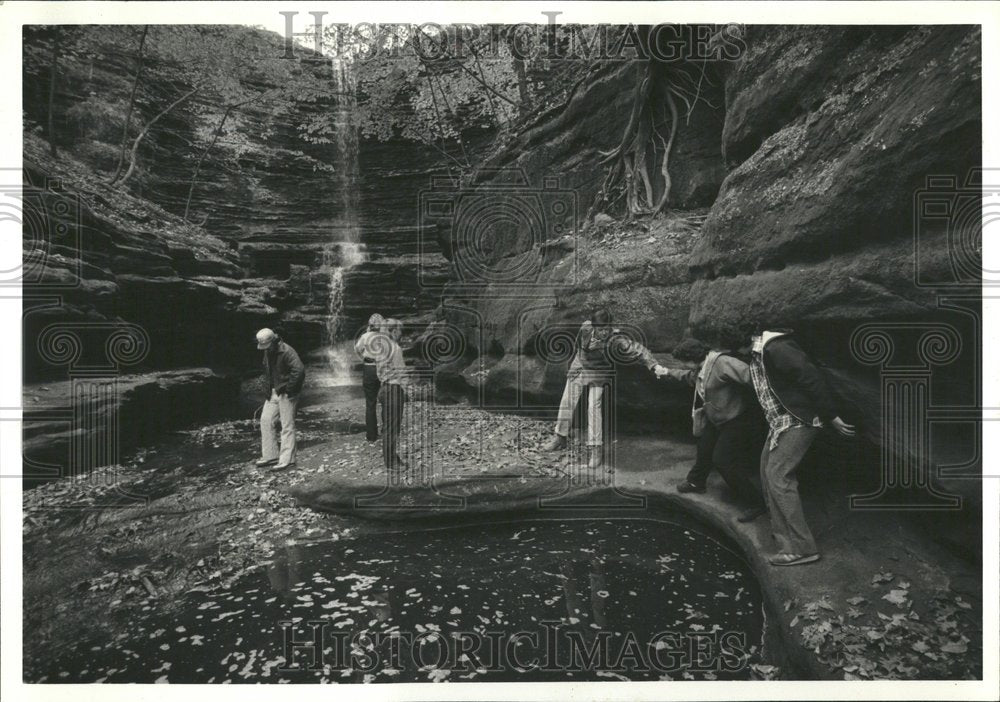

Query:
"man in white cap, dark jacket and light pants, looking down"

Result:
[[257, 329, 306, 470]]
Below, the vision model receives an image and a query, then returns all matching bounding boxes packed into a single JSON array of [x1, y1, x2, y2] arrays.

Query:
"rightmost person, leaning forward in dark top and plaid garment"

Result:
[[750, 331, 854, 566]]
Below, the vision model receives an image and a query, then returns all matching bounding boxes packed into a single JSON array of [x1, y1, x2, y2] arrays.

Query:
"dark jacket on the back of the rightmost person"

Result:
[[762, 335, 837, 424]]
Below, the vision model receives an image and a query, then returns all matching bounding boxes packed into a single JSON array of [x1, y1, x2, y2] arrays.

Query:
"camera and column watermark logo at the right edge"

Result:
[[850, 169, 1000, 510]]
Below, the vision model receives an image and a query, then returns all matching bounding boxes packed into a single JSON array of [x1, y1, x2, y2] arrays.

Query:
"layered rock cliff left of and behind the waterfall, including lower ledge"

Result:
[[23, 29, 448, 473]]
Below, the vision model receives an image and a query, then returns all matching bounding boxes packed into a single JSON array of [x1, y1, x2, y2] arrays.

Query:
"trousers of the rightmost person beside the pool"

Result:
[[760, 427, 819, 556]]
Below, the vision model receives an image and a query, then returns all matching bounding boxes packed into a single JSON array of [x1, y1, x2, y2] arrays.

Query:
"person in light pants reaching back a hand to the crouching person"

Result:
[[542, 309, 659, 469]]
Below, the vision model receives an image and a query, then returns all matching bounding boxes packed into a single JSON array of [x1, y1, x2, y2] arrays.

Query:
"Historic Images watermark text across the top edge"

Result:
[[279, 11, 746, 62]]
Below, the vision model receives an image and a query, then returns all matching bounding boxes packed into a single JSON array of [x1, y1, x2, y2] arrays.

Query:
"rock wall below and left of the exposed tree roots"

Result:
[[422, 63, 725, 426]]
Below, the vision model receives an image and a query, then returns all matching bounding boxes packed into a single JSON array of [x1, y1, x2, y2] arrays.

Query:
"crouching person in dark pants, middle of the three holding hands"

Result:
[[656, 350, 767, 522]]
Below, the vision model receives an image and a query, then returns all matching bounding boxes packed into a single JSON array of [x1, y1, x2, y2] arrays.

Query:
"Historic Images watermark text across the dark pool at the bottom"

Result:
[[277, 619, 750, 675]]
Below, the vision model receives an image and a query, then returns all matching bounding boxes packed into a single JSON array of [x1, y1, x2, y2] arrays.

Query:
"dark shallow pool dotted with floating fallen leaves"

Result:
[[35, 518, 763, 683]]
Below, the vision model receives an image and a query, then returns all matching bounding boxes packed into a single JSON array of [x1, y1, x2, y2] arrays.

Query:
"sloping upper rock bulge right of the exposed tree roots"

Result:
[[691, 27, 981, 277]]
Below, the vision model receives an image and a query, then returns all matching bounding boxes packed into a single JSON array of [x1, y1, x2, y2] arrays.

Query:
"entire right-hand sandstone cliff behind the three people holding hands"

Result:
[[434, 26, 982, 540]]
